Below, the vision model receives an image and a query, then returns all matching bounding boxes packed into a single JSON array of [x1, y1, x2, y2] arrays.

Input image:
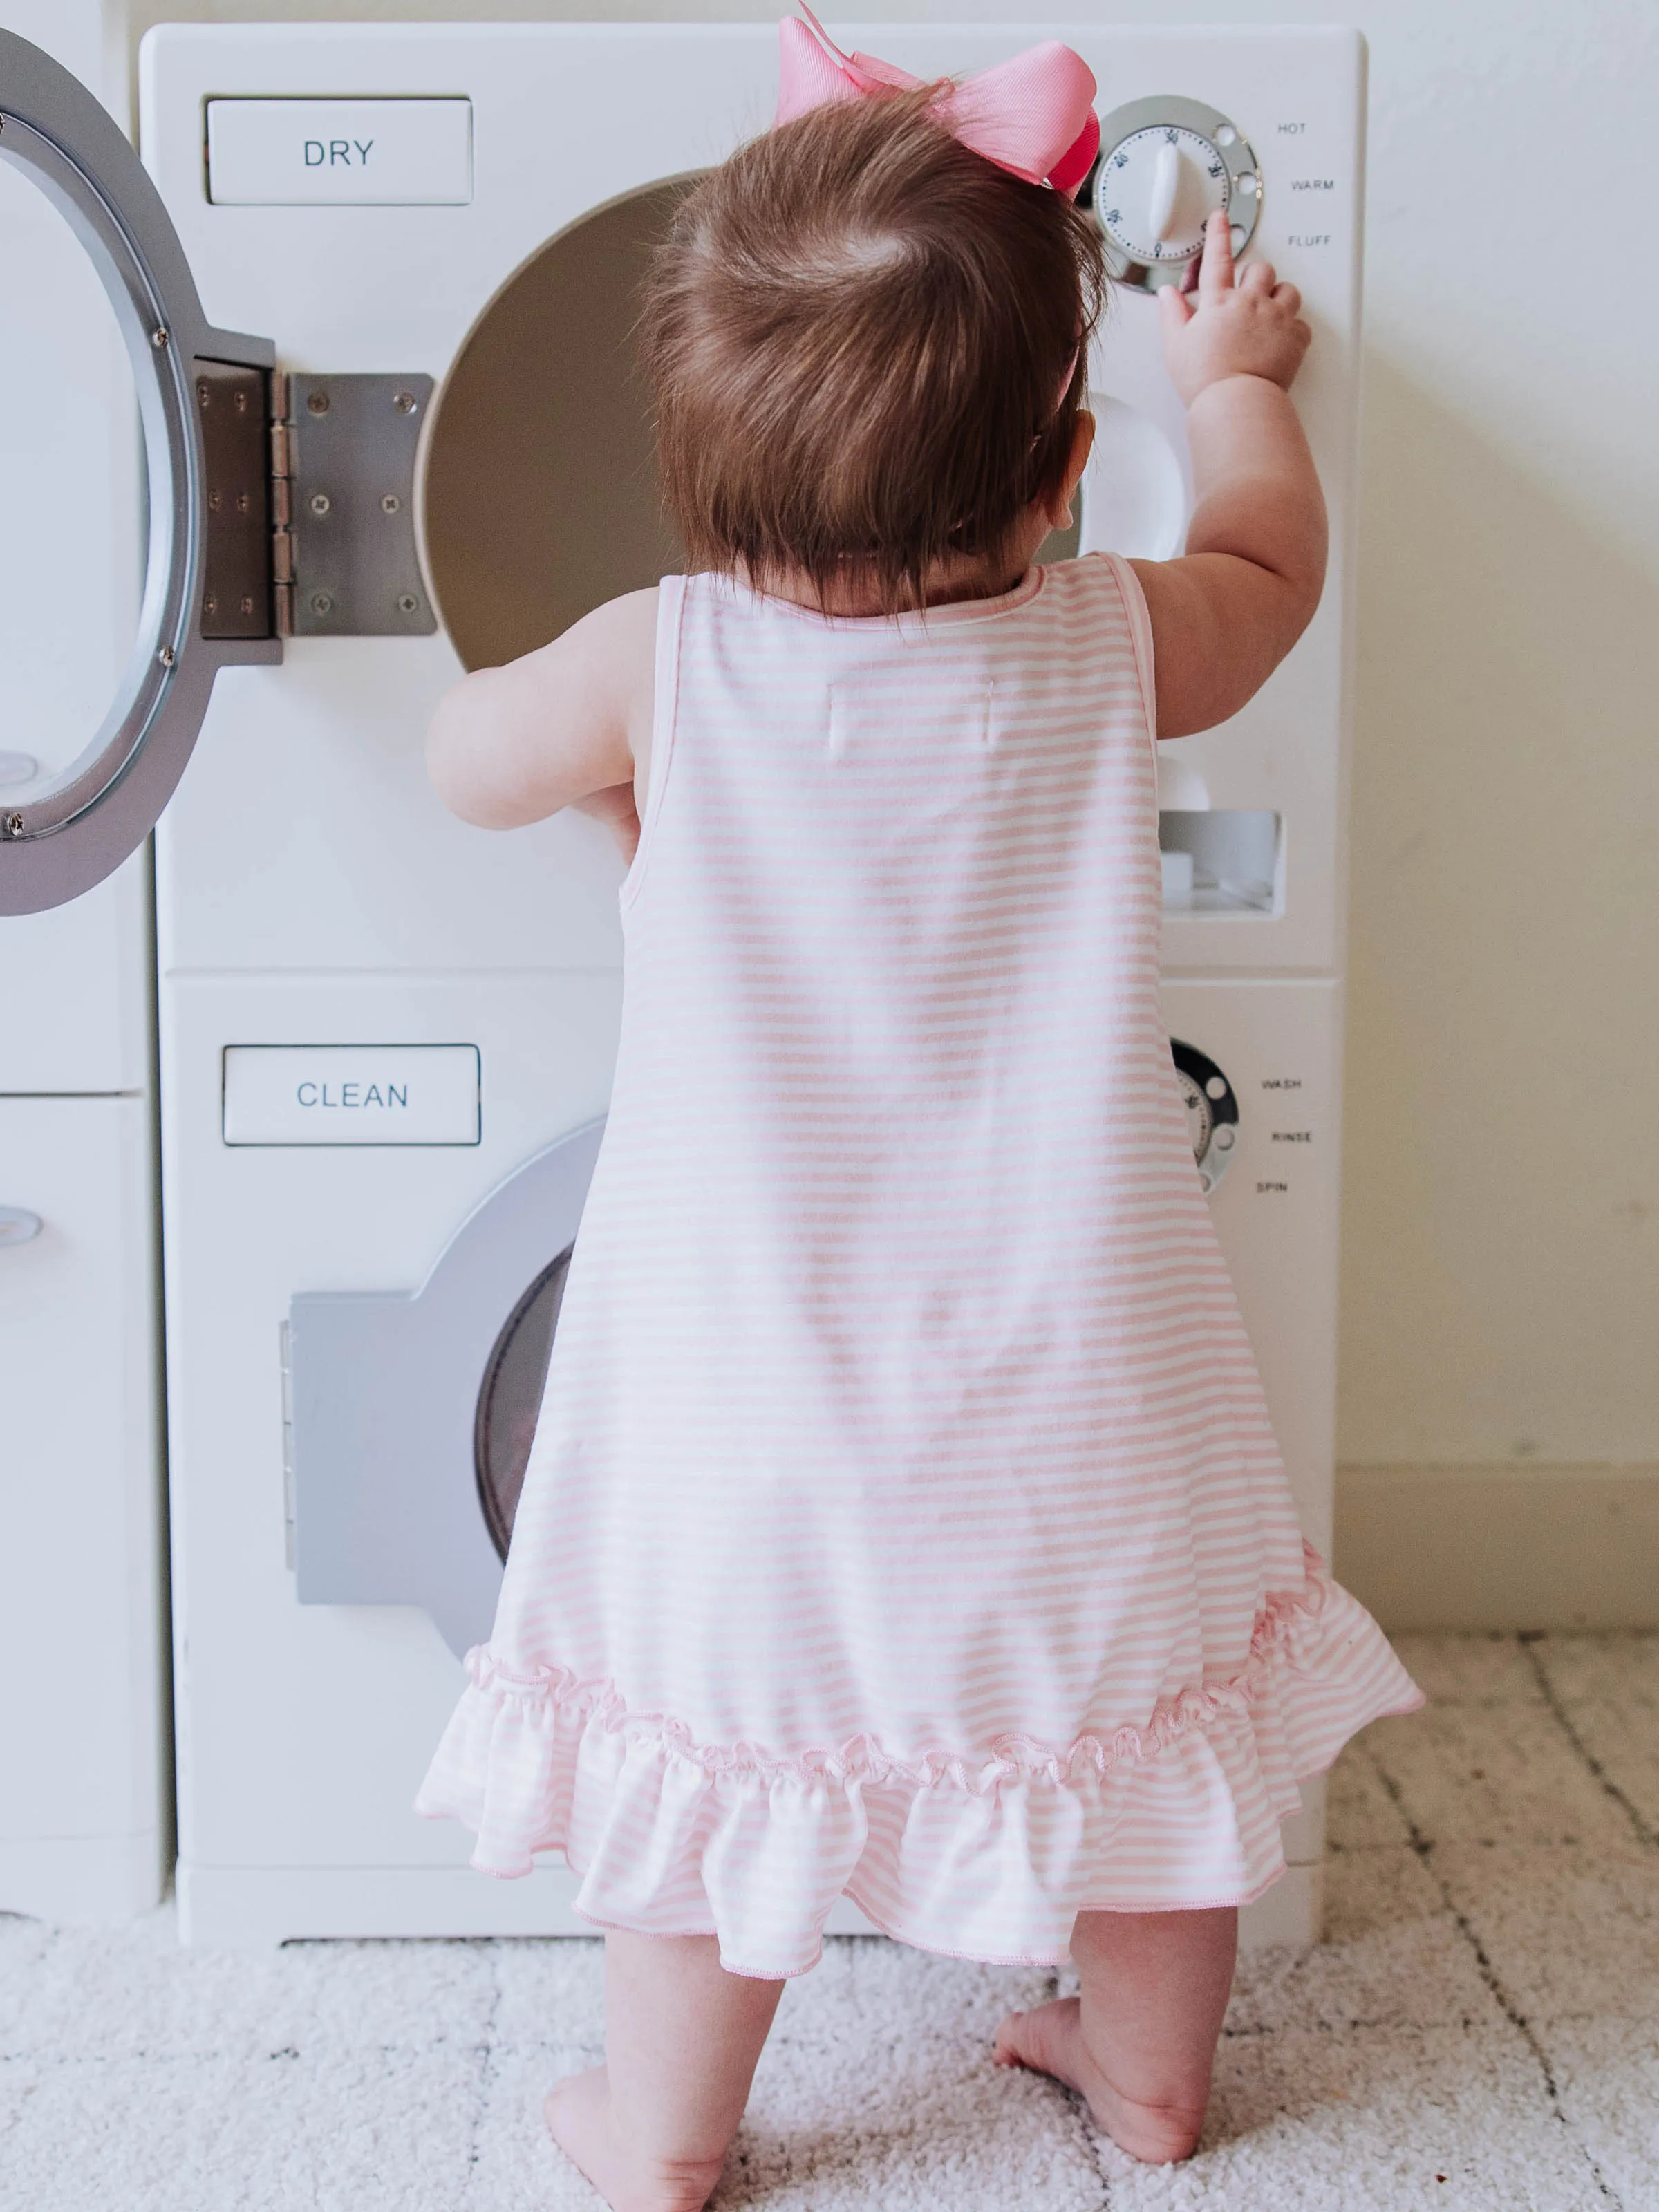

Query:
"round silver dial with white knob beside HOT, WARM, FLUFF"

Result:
[[1093, 95, 1261, 290]]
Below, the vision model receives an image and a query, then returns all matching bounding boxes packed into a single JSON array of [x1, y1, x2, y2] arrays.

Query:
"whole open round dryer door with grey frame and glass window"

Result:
[[0, 31, 281, 916]]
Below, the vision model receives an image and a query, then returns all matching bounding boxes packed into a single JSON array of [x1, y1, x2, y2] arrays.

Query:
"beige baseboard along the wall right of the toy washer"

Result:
[[1334, 1462, 1659, 1630]]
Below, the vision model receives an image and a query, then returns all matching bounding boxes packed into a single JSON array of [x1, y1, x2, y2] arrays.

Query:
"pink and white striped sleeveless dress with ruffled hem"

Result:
[[420, 555, 1418, 1976]]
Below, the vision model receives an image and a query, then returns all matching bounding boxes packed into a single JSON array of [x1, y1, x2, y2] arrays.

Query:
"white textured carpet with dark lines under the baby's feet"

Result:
[[0, 1637, 1659, 2212]]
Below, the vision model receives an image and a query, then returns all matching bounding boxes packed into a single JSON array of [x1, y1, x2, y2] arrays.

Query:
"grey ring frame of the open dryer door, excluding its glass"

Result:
[[0, 31, 281, 914]]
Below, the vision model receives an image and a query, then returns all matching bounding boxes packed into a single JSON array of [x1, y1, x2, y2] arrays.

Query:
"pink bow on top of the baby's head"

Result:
[[772, 0, 1099, 199]]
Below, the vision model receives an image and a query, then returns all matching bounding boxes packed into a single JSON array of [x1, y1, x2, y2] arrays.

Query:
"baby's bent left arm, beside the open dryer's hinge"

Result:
[[427, 588, 657, 845]]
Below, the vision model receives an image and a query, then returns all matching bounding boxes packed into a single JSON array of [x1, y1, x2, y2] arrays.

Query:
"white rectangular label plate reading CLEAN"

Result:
[[223, 1044, 480, 1143]]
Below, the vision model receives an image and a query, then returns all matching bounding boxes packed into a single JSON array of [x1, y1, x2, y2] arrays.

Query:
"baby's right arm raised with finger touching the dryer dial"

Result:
[[1135, 217, 1325, 737]]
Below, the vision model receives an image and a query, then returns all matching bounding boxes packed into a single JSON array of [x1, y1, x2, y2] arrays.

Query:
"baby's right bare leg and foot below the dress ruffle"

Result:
[[995, 1906, 1239, 2166]]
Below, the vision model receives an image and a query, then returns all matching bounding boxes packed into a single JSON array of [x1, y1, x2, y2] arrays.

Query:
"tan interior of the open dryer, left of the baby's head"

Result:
[[418, 177, 695, 668]]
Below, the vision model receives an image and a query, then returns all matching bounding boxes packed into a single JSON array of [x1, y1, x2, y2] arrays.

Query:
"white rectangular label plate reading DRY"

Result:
[[208, 100, 474, 208]]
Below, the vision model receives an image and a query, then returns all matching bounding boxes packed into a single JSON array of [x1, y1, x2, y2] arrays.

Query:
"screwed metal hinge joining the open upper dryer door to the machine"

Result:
[[195, 361, 438, 637]]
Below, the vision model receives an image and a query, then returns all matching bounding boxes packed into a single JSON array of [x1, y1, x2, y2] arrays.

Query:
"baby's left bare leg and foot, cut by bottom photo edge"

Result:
[[546, 1933, 783, 2212]]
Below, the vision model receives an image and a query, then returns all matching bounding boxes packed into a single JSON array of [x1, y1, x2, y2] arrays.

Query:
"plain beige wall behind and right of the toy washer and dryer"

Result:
[[97, 0, 1659, 1467]]
